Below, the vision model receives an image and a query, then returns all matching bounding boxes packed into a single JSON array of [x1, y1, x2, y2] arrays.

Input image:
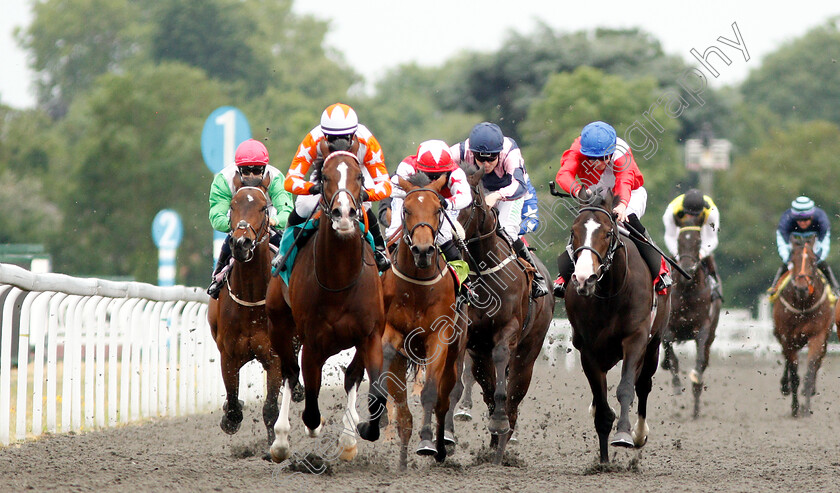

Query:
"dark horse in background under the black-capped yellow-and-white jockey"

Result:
[[662, 216, 722, 419]]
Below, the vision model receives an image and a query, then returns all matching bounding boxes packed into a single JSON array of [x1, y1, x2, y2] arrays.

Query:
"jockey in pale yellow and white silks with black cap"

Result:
[[662, 188, 723, 300]]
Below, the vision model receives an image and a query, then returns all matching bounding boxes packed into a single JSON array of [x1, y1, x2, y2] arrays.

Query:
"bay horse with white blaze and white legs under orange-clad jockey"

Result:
[[266, 151, 387, 462]]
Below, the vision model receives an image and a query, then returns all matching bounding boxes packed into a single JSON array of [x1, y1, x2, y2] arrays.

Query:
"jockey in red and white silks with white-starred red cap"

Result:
[[385, 140, 472, 261]]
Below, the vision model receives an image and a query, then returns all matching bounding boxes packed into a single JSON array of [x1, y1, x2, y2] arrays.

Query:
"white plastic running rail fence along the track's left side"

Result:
[[0, 264, 233, 445]]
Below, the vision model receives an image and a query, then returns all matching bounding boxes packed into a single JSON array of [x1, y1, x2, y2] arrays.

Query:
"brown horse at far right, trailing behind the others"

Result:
[[773, 233, 834, 417]]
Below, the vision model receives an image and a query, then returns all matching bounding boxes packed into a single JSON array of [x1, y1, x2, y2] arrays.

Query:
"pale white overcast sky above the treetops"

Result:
[[0, 0, 840, 108]]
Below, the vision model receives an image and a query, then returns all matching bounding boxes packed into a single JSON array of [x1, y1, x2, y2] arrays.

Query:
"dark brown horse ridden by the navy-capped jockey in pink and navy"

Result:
[[446, 164, 554, 464]]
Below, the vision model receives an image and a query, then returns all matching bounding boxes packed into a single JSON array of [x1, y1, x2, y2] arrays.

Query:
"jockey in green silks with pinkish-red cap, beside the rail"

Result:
[[207, 139, 292, 299]]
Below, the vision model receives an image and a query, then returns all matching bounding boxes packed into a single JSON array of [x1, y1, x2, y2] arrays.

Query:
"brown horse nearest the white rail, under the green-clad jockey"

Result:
[[207, 181, 281, 450]]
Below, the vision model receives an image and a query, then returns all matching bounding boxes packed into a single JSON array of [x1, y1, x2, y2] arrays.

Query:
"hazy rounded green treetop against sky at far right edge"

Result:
[[741, 17, 840, 124]]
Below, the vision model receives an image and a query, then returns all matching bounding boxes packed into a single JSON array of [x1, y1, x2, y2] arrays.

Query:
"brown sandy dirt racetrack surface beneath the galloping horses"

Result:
[[0, 355, 840, 492]]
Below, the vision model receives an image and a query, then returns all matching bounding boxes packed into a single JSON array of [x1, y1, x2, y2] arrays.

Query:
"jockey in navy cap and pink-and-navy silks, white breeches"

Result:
[[450, 122, 548, 298]]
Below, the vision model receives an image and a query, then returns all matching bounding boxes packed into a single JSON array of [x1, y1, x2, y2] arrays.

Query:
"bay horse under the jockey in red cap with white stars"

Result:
[[382, 173, 466, 469]]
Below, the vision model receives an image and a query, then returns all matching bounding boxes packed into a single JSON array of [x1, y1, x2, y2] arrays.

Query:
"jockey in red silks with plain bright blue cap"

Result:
[[554, 121, 672, 298]]
